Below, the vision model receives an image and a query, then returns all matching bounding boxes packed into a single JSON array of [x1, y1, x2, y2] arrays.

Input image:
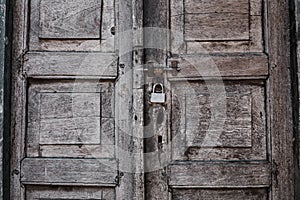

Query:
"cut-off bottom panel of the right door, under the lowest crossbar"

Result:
[[172, 188, 268, 200]]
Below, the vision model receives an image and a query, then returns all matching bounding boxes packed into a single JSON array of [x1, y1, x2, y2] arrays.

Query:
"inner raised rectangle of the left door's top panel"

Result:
[[39, 0, 102, 39]]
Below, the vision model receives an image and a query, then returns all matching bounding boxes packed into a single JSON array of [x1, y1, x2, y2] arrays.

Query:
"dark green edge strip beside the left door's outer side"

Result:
[[0, 0, 13, 200]]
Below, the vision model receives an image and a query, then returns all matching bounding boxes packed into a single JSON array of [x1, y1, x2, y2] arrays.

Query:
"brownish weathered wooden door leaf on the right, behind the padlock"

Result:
[[145, 0, 297, 200]]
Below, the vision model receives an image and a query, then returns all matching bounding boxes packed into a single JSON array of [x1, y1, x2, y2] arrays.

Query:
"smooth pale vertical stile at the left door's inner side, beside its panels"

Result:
[[115, 0, 136, 199]]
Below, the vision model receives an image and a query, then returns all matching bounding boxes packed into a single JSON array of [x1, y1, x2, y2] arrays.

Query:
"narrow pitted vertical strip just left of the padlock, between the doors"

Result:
[[132, 0, 145, 200]]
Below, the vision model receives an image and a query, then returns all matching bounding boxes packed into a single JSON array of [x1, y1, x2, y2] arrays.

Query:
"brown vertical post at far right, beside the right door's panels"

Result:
[[268, 0, 299, 199]]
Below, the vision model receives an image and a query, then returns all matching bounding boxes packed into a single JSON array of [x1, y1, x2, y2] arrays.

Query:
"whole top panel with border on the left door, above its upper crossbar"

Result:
[[29, 0, 116, 52]]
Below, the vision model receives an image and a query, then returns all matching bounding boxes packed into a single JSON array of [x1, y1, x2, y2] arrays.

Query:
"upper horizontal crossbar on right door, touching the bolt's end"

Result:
[[169, 54, 269, 79]]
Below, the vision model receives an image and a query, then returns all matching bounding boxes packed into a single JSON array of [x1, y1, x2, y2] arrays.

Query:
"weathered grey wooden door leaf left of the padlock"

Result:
[[11, 0, 143, 200]]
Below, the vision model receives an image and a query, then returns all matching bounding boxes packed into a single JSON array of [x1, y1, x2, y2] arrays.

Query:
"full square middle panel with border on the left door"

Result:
[[27, 80, 115, 157]]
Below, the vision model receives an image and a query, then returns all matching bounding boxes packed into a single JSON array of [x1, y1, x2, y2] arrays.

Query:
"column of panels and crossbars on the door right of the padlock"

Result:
[[162, 0, 271, 200]]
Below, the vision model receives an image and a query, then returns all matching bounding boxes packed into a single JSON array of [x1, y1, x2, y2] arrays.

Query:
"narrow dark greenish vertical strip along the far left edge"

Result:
[[0, 0, 12, 199]]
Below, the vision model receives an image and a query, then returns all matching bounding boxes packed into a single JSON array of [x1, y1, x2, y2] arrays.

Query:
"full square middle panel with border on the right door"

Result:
[[171, 81, 267, 160]]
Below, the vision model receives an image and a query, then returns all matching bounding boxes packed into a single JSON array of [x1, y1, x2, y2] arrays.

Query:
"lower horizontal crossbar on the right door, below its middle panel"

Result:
[[169, 162, 270, 188]]
